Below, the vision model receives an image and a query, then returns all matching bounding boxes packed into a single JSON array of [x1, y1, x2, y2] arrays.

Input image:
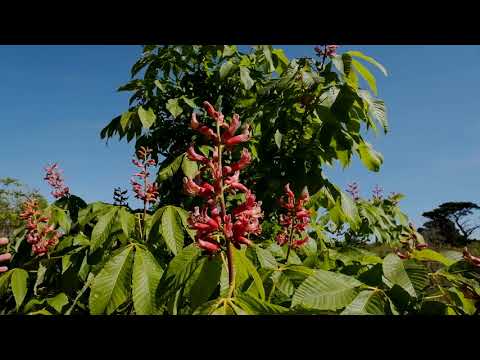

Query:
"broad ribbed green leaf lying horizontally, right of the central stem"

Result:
[[292, 270, 362, 310]]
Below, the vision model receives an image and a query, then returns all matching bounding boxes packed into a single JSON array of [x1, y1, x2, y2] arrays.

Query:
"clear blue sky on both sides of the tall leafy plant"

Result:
[[0, 45, 480, 225]]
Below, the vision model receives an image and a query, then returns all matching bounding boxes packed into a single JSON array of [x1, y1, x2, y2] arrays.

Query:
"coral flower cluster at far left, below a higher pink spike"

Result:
[[20, 199, 60, 256]]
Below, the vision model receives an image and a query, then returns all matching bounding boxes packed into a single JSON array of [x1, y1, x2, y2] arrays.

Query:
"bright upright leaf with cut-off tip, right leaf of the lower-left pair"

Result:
[[132, 246, 163, 315]]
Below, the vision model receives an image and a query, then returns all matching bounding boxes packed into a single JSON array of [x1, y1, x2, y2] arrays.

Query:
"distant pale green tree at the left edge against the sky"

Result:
[[0, 177, 47, 237]]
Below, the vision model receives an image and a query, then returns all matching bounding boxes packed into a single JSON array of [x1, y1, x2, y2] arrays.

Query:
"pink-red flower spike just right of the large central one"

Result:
[[276, 184, 310, 248]]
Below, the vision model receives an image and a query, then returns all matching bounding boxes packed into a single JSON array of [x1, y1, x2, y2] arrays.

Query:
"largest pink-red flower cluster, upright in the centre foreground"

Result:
[[183, 102, 263, 253]]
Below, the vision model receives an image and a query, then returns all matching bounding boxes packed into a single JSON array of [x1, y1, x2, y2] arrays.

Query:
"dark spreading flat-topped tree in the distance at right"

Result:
[[420, 202, 480, 245]]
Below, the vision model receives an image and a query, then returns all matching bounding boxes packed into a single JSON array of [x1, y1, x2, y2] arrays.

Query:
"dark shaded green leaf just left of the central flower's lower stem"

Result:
[[190, 256, 222, 309]]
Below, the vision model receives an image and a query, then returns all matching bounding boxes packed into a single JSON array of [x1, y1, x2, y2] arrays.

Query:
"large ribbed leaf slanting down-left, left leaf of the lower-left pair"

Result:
[[89, 246, 133, 315]]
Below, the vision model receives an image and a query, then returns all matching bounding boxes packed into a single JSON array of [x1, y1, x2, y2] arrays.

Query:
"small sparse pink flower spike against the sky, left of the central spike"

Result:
[[130, 146, 158, 204]]
